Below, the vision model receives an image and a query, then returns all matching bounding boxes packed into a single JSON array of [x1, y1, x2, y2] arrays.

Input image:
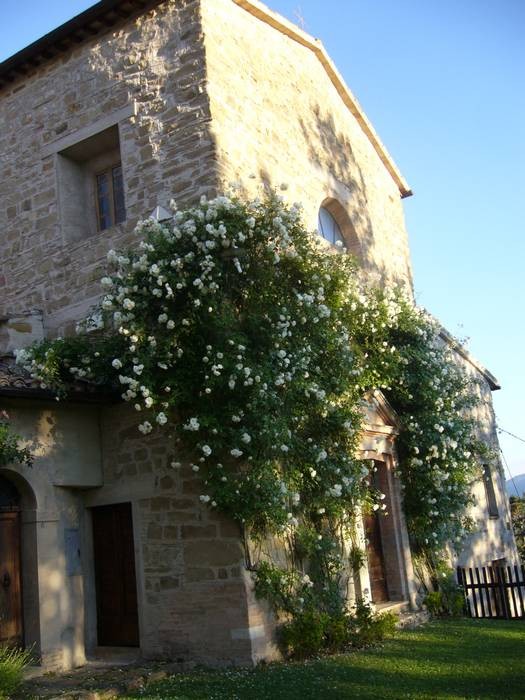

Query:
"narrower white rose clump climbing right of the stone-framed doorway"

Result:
[[360, 304, 493, 552]]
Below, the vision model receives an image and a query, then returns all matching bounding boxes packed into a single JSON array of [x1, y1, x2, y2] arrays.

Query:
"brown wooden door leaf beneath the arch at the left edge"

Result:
[[0, 510, 23, 645]]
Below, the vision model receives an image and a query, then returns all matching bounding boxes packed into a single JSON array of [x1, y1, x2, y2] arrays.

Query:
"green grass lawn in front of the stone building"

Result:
[[126, 620, 525, 700]]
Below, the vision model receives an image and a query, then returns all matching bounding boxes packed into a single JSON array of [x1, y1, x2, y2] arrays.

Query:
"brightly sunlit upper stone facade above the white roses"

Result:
[[202, 0, 411, 285]]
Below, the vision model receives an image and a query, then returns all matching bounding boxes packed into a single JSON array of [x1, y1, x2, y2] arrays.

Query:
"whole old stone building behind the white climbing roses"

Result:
[[0, 0, 516, 668]]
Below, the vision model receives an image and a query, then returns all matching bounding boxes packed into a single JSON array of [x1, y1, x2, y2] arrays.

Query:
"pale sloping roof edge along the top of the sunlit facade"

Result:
[[233, 0, 412, 198]]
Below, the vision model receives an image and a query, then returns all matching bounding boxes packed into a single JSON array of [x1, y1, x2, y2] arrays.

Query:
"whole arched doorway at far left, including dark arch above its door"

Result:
[[0, 469, 40, 654]]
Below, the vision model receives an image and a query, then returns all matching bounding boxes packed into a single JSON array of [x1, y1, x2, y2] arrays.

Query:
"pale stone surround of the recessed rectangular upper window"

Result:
[[41, 101, 137, 245]]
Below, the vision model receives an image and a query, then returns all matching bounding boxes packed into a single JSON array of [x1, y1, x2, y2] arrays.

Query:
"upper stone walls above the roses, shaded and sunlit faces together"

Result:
[[0, 0, 418, 335]]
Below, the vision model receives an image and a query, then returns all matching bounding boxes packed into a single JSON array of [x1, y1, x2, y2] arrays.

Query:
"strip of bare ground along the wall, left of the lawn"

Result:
[[15, 662, 195, 700]]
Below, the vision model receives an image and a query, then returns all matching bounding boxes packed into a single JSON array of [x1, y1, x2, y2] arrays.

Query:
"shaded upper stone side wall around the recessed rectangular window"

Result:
[[0, 0, 215, 335]]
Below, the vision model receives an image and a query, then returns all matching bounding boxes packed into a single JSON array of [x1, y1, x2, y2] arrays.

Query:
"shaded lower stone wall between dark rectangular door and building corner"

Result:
[[85, 406, 255, 664]]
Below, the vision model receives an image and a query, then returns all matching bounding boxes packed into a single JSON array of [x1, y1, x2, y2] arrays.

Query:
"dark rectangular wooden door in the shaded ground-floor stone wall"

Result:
[[92, 503, 139, 647]]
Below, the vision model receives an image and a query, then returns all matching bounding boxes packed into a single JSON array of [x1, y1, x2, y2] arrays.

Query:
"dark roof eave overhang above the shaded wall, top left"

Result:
[[0, 0, 164, 89]]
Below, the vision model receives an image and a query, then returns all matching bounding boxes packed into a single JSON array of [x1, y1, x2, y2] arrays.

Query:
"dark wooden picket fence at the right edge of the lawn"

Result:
[[457, 566, 525, 620]]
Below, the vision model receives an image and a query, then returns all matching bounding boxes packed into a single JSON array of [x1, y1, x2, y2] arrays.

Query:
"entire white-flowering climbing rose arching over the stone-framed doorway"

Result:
[[19, 189, 488, 576]]
